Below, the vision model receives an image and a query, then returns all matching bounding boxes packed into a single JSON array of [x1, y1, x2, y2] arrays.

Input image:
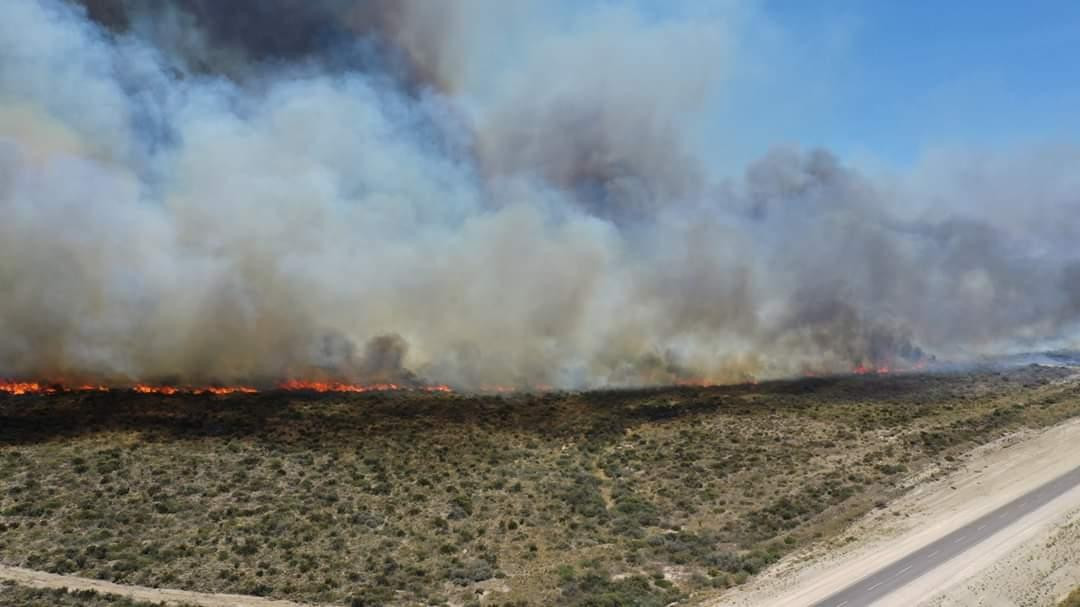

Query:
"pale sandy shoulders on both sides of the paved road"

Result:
[[707, 397, 1080, 607]]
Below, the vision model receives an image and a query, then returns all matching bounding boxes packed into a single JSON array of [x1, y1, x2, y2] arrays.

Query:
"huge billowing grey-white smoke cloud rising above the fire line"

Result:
[[0, 0, 1080, 389]]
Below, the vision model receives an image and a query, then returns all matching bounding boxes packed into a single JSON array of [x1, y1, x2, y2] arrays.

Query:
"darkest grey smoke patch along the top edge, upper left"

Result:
[[71, 0, 456, 93]]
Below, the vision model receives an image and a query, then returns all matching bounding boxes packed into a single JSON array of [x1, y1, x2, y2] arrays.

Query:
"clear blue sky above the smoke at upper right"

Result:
[[686, 0, 1080, 172]]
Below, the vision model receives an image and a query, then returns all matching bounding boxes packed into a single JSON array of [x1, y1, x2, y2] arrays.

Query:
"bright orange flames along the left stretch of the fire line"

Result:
[[0, 379, 454, 396]]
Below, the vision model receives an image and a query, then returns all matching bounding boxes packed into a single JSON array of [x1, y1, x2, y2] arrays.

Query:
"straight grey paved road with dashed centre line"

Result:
[[812, 468, 1080, 607]]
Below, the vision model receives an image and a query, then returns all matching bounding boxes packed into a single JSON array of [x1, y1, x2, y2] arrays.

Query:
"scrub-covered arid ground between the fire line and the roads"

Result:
[[0, 366, 1080, 606]]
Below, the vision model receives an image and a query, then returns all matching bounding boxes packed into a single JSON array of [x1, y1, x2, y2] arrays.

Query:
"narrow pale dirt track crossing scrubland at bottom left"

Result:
[[0, 565, 315, 607]]
